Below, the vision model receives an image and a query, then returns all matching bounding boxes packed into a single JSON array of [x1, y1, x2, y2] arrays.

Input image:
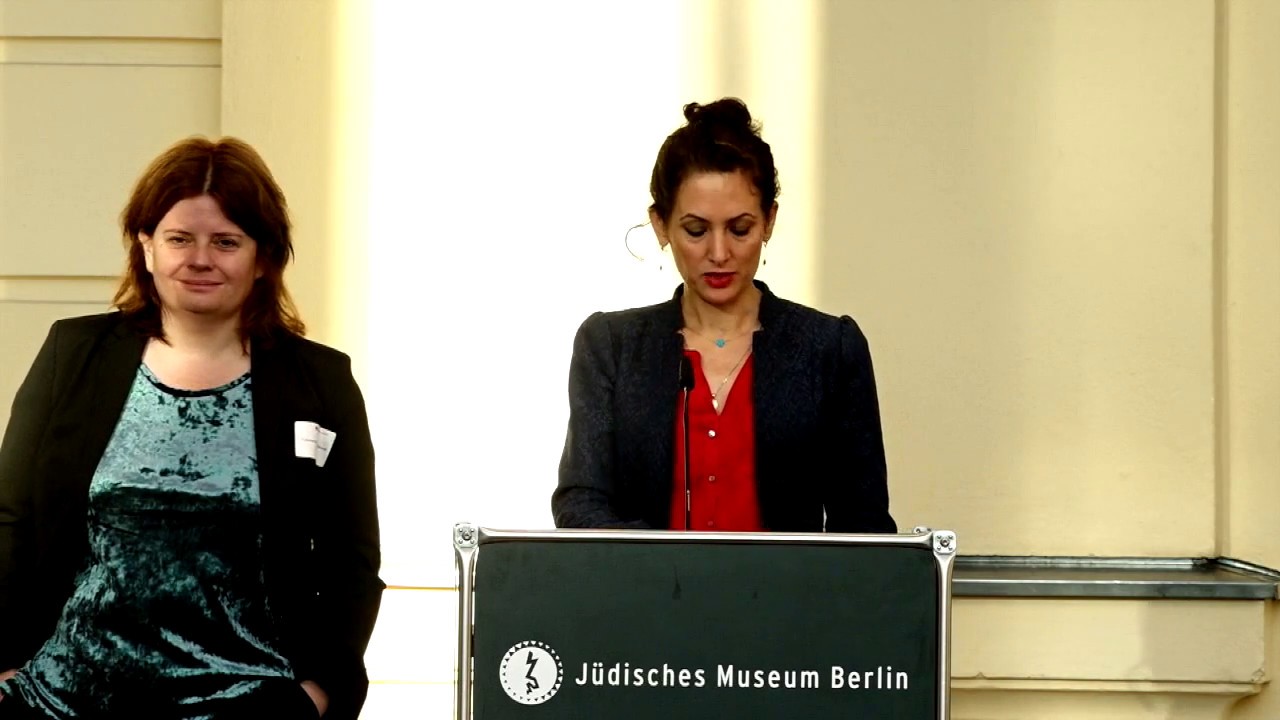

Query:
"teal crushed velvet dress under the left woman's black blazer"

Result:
[[0, 365, 300, 720]]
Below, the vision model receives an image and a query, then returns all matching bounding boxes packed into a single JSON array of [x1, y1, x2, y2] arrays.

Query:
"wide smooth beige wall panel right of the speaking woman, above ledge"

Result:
[[817, 0, 1216, 556]]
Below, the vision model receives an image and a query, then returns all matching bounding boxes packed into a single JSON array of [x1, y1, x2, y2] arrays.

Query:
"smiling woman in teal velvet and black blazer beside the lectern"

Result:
[[0, 137, 384, 720]]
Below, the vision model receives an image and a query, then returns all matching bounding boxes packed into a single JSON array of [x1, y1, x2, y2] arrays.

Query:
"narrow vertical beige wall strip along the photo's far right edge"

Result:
[[1219, 0, 1280, 571]]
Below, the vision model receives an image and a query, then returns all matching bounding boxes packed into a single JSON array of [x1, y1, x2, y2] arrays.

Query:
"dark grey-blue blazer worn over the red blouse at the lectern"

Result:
[[552, 282, 897, 533]]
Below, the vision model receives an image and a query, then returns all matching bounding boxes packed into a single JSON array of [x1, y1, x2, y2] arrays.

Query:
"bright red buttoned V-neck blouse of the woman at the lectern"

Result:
[[671, 350, 763, 532]]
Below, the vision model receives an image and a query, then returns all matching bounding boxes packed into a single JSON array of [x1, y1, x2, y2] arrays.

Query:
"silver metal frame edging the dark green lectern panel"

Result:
[[453, 523, 956, 720]]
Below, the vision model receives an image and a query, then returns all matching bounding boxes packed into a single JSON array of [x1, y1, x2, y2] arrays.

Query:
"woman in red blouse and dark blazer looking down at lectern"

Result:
[[552, 99, 896, 533]]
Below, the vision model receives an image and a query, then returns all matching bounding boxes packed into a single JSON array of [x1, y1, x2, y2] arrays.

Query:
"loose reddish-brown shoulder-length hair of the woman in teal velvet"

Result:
[[111, 137, 306, 343]]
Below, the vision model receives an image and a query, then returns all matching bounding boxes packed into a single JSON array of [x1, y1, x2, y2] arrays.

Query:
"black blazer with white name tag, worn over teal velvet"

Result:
[[0, 313, 385, 720]]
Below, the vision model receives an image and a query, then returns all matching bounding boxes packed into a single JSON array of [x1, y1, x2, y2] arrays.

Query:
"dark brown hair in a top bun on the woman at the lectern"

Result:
[[649, 97, 778, 220]]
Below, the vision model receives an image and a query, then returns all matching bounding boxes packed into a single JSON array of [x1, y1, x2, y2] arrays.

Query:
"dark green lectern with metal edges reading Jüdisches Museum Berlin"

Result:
[[453, 524, 956, 720]]
